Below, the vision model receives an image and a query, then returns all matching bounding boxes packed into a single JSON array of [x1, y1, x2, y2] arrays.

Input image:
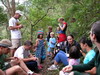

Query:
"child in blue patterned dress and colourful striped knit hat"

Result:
[[35, 30, 46, 63]]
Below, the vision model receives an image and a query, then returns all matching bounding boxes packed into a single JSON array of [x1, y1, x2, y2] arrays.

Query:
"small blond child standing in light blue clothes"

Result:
[[48, 32, 56, 57]]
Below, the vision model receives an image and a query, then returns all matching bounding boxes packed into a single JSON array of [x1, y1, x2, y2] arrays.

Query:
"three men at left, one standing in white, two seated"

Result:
[[0, 10, 41, 75]]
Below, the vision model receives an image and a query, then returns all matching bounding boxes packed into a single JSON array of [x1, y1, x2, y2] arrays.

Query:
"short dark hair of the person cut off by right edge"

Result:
[[92, 21, 100, 43]]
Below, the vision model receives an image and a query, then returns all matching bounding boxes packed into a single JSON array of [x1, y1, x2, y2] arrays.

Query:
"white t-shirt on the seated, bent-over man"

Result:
[[14, 46, 30, 59]]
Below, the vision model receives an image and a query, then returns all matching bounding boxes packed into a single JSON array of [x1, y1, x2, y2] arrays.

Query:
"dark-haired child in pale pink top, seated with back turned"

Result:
[[69, 46, 80, 65]]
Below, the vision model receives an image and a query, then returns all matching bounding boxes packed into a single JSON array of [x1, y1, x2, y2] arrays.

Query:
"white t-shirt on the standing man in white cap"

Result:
[[9, 17, 21, 39]]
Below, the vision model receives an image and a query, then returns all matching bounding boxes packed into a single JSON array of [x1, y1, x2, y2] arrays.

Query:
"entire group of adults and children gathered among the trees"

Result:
[[0, 10, 100, 75]]
